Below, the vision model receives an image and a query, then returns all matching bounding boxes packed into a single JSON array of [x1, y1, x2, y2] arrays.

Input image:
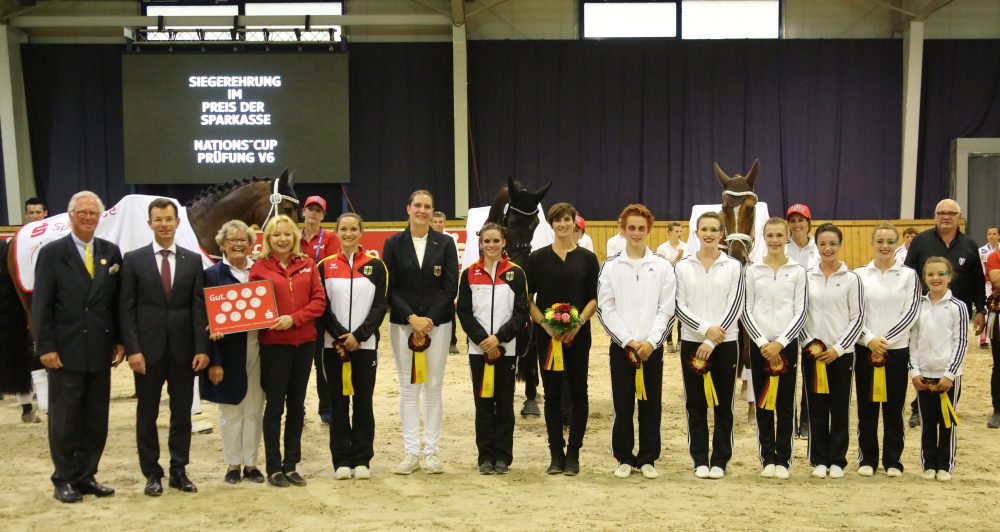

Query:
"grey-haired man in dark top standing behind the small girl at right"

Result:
[[904, 199, 996, 428]]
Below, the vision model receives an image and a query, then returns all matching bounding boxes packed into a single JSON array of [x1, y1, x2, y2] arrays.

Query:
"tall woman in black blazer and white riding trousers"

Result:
[[382, 190, 458, 475]]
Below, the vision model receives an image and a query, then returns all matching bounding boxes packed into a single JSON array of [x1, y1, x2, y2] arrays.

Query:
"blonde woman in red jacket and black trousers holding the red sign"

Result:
[[250, 216, 326, 488]]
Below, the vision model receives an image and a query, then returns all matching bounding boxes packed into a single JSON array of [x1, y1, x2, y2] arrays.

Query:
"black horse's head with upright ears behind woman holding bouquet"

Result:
[[482, 177, 552, 264]]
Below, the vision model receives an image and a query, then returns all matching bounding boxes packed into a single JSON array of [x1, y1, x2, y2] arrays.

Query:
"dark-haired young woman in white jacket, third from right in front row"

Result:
[[801, 224, 864, 478]]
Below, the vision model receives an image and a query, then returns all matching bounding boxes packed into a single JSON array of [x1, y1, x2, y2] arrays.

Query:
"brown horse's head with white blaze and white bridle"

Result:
[[715, 159, 760, 264]]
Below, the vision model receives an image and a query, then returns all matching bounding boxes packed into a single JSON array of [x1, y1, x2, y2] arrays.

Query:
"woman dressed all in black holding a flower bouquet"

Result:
[[525, 203, 599, 476]]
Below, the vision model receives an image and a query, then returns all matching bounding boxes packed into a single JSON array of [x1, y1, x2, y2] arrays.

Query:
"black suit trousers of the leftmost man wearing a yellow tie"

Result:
[[48, 368, 111, 486]]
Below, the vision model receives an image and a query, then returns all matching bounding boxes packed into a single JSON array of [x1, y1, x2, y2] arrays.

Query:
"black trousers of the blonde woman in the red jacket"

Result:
[[260, 342, 315, 475]]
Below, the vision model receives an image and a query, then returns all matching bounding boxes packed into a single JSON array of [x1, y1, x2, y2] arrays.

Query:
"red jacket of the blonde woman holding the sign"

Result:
[[250, 255, 326, 345]]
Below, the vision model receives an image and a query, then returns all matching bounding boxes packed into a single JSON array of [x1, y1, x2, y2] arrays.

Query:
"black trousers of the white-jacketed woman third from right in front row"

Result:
[[802, 353, 854, 468]]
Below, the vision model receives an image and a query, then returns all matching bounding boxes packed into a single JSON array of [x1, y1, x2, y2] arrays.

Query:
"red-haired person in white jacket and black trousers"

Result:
[[597, 204, 677, 479]]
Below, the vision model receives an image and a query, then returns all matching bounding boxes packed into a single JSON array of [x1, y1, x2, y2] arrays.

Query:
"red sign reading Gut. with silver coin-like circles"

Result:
[[205, 280, 278, 334]]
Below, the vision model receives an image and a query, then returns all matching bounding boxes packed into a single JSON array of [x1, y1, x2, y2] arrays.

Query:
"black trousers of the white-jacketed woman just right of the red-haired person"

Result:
[[680, 340, 740, 469]]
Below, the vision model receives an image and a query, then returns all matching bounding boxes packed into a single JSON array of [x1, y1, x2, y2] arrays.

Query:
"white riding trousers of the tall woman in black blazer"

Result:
[[389, 323, 454, 455]]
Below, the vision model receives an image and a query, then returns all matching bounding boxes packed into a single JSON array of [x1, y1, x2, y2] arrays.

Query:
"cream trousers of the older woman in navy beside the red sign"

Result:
[[219, 334, 264, 466]]
